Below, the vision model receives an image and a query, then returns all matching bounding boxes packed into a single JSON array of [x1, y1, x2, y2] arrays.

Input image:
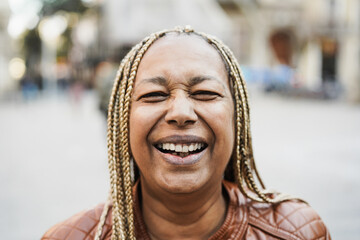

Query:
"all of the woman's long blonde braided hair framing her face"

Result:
[[95, 26, 291, 240]]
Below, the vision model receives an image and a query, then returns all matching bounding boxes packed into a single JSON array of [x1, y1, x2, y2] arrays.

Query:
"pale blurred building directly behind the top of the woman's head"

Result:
[[101, 0, 232, 55]]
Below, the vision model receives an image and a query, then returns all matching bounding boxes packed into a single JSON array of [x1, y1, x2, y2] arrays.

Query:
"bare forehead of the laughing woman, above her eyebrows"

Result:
[[137, 35, 227, 79]]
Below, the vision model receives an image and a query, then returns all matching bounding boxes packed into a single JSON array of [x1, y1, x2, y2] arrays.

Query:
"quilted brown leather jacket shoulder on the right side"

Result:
[[248, 200, 331, 240]]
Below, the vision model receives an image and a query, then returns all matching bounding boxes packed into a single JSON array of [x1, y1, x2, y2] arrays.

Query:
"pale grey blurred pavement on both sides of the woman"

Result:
[[0, 89, 360, 240]]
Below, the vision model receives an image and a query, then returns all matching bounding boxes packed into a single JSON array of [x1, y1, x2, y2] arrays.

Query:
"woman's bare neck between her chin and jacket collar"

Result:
[[141, 180, 226, 240]]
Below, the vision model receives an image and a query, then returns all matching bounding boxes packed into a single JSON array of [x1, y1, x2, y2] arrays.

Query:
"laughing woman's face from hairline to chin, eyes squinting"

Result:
[[130, 36, 234, 193]]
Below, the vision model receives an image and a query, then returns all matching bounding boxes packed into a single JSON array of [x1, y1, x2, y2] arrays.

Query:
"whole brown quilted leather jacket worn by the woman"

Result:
[[42, 181, 331, 240]]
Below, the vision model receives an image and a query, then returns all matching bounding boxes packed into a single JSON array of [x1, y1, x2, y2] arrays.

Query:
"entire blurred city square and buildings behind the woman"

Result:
[[0, 0, 360, 240]]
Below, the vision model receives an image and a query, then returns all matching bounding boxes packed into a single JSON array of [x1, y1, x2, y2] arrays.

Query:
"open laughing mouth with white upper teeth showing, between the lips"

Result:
[[155, 142, 207, 158]]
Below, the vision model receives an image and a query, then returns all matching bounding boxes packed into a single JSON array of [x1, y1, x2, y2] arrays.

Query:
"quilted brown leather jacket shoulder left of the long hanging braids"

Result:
[[41, 203, 111, 240]]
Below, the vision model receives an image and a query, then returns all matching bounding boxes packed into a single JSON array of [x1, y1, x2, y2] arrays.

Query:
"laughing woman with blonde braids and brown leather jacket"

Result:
[[42, 27, 330, 240]]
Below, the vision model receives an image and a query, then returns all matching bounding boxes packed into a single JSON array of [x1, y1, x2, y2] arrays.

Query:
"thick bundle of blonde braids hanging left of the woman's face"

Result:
[[103, 34, 165, 240]]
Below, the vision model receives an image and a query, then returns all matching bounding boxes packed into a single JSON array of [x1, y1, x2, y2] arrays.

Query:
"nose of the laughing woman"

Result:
[[165, 94, 198, 127]]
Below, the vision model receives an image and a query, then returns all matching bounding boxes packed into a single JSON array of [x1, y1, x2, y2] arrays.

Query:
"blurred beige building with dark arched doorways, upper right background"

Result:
[[218, 0, 360, 101]]
